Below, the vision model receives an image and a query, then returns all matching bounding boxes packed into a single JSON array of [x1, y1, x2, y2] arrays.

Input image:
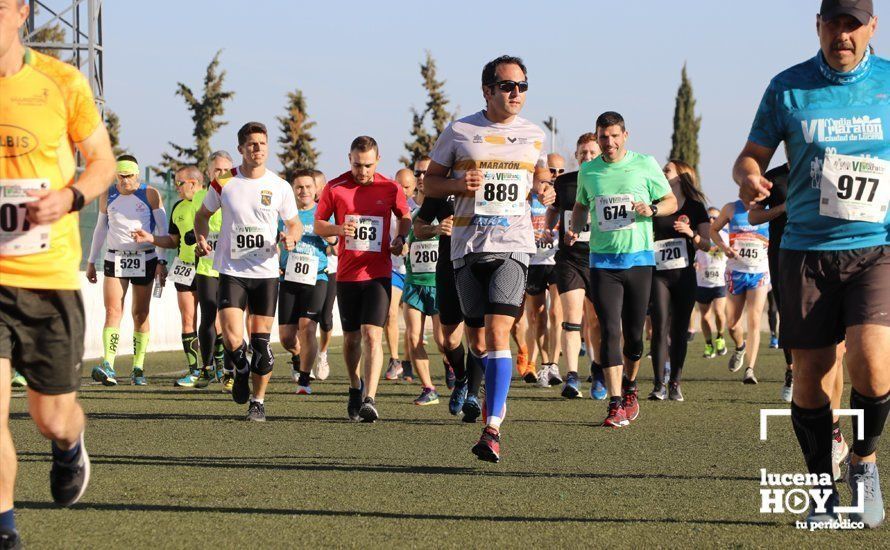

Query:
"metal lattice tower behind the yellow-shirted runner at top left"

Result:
[[23, 0, 105, 113]]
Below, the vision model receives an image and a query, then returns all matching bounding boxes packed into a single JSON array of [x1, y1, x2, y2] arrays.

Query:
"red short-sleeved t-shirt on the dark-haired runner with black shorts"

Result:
[[315, 172, 408, 282]]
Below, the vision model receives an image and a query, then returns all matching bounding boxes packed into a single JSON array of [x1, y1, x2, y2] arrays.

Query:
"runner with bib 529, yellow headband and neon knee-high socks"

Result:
[[86, 155, 167, 386]]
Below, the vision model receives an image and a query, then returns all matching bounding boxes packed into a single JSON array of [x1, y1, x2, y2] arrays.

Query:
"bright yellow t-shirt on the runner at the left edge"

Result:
[[0, 49, 101, 290]]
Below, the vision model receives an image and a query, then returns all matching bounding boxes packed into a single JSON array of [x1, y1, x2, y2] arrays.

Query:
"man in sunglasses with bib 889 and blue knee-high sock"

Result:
[[424, 56, 554, 462]]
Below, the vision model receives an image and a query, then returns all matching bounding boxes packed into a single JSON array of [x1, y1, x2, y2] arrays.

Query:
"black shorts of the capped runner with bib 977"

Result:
[[779, 246, 890, 349]]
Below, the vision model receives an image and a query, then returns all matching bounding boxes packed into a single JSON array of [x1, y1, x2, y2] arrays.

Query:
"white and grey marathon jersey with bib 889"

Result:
[[430, 111, 545, 260]]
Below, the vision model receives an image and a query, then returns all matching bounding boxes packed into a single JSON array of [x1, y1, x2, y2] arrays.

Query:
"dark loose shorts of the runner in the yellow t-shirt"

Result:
[[0, 286, 84, 395]]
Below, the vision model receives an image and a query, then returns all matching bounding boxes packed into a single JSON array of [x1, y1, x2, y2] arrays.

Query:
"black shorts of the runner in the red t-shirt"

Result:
[[337, 277, 392, 332]]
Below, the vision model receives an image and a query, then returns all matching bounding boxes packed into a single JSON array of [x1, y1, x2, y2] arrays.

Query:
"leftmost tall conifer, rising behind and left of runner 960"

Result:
[[156, 50, 235, 174]]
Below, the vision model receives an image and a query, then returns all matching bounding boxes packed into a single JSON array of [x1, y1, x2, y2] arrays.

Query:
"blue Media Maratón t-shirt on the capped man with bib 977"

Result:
[[748, 52, 890, 250]]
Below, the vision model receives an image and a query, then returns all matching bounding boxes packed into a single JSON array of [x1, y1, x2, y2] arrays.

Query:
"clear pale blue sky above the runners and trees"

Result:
[[86, 0, 890, 207]]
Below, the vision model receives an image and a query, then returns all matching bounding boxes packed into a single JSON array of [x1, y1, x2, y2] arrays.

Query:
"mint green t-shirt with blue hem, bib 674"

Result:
[[576, 151, 671, 269]]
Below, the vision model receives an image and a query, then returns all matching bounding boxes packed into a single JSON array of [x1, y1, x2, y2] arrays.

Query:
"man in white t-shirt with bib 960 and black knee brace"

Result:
[[195, 122, 303, 422]]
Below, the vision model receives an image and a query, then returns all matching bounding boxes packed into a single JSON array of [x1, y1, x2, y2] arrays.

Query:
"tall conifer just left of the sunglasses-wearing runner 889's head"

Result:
[[399, 50, 454, 166]]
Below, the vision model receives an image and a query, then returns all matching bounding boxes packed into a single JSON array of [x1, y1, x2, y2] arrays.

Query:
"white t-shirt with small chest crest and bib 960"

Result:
[[204, 168, 299, 279]]
